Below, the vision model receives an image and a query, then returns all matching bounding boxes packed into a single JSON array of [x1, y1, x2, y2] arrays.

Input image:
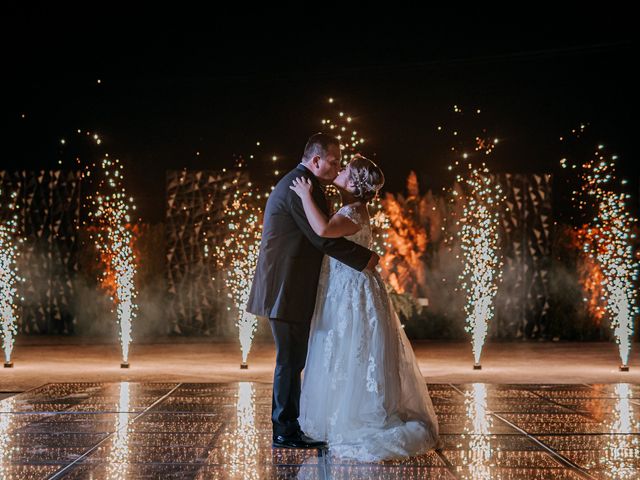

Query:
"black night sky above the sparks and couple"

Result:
[[0, 4, 639, 221]]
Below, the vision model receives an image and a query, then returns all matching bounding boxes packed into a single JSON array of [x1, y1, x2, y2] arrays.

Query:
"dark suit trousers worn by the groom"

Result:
[[269, 318, 311, 435]]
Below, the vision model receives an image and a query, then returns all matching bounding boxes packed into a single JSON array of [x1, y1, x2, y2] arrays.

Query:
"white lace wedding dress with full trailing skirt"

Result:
[[298, 205, 438, 462]]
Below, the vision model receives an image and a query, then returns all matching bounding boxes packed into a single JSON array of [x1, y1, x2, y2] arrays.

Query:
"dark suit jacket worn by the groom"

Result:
[[247, 164, 372, 322]]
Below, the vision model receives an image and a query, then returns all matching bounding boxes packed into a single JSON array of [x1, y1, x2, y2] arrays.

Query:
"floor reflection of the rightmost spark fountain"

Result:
[[592, 383, 640, 480]]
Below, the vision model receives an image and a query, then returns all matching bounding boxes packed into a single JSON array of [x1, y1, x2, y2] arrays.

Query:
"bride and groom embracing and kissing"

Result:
[[247, 133, 439, 462]]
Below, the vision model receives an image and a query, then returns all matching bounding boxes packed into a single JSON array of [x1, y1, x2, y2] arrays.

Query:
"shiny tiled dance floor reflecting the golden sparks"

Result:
[[0, 382, 640, 480]]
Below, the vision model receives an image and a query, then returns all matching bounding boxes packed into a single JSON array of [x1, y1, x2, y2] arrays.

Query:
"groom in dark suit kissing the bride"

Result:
[[247, 133, 379, 448]]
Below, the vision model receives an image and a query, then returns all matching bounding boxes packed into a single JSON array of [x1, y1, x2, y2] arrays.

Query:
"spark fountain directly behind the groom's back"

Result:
[[216, 188, 262, 364]]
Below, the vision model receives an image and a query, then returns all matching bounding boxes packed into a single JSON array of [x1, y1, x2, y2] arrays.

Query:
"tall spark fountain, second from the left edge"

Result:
[[93, 155, 137, 363]]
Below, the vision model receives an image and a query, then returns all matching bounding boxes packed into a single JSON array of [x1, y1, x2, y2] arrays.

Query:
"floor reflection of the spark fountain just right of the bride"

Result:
[[458, 383, 497, 480]]
